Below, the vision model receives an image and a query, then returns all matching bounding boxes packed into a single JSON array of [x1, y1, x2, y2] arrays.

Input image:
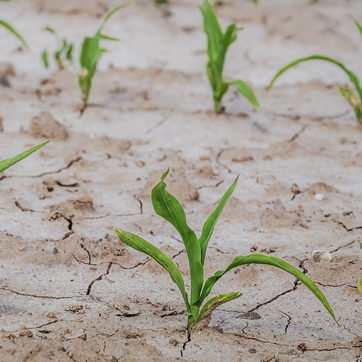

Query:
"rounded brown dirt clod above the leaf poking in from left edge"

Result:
[[26, 112, 68, 141]]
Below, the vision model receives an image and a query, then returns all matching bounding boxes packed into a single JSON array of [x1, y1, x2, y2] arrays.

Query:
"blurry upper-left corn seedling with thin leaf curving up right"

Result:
[[78, 3, 128, 111]]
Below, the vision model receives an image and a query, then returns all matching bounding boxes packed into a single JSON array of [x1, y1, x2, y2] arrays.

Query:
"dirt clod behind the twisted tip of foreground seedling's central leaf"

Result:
[[138, 169, 200, 204]]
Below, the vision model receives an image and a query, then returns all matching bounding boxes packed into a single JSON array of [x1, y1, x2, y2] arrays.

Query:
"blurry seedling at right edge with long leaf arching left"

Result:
[[268, 20, 362, 124]]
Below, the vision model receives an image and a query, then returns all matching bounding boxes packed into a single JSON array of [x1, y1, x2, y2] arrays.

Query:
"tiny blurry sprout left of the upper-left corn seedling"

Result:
[[41, 26, 74, 70]]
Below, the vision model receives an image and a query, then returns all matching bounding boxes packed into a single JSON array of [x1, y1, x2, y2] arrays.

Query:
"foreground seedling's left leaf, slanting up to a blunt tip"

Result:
[[115, 229, 190, 311]]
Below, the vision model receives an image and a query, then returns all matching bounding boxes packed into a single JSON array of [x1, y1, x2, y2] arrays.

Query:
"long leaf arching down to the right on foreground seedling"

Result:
[[195, 254, 338, 324]]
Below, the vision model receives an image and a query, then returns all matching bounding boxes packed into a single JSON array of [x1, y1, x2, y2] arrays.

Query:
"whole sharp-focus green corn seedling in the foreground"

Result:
[[115, 171, 336, 332]]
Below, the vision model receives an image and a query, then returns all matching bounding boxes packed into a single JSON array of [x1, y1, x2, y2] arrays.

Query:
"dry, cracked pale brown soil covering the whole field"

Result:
[[0, 0, 362, 362]]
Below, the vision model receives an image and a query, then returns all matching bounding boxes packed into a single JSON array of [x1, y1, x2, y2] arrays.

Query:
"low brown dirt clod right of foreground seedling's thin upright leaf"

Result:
[[260, 199, 309, 229]]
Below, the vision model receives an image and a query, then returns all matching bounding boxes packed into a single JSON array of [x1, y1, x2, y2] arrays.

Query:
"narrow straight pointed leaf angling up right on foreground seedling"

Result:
[[199, 176, 239, 264]]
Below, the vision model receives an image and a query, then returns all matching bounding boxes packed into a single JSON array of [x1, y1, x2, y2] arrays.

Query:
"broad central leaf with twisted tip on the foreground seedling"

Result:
[[152, 170, 204, 303]]
